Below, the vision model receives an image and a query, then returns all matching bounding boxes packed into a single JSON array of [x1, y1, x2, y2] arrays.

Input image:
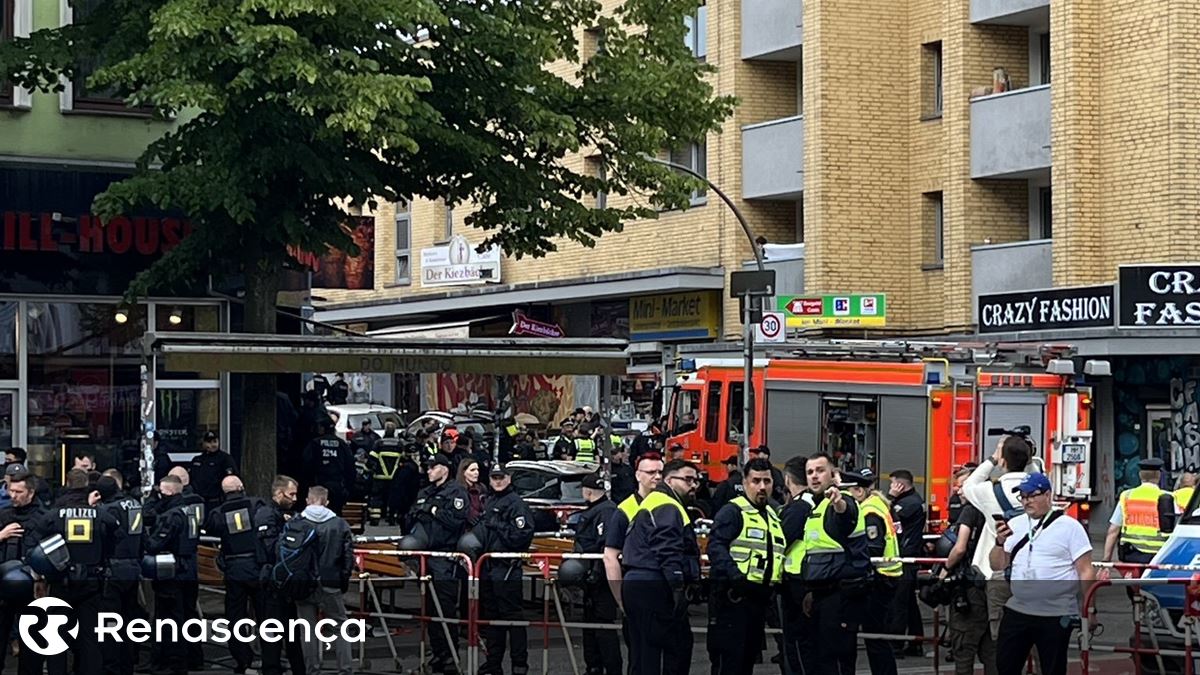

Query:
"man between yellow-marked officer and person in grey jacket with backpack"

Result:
[[253, 476, 305, 675]]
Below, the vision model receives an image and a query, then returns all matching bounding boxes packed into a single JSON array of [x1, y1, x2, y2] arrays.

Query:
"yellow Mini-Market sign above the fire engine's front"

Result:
[[629, 291, 720, 342]]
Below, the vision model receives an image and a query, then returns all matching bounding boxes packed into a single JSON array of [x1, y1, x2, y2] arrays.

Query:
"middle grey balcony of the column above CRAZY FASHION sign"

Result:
[[971, 84, 1050, 178]]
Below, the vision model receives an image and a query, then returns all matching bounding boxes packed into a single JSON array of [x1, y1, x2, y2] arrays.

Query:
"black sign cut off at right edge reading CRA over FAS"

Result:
[[1118, 264, 1200, 328]]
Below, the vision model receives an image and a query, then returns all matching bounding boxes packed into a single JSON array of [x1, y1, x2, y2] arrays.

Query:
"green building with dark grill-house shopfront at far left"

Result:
[[0, 0, 230, 477]]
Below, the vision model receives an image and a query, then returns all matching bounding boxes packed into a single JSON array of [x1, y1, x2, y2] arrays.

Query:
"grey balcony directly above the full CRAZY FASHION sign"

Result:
[[971, 239, 1054, 321]]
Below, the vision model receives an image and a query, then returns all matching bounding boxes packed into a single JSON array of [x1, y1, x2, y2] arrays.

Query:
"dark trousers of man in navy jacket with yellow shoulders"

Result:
[[620, 571, 692, 675]]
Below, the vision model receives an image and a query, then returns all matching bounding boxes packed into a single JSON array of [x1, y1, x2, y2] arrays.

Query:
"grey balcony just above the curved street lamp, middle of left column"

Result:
[[742, 115, 804, 201]]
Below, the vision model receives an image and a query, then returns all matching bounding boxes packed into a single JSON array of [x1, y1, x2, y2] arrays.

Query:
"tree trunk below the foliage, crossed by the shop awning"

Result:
[[241, 259, 280, 495]]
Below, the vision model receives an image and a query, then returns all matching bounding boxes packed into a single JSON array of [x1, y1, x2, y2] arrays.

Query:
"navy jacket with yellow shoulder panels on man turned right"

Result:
[[622, 485, 700, 585]]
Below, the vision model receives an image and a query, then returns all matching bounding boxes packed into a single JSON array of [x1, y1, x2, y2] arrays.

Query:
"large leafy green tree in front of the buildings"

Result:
[[0, 0, 734, 489]]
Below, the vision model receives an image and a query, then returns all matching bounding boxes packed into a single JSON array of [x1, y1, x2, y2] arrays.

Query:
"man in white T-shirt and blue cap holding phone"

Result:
[[988, 473, 1094, 675]]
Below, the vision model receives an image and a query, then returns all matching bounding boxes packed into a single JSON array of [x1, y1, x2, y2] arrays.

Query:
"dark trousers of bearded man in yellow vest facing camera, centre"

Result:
[[706, 585, 770, 675]]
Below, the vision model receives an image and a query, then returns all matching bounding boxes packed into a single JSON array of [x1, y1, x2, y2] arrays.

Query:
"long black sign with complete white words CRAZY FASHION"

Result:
[[977, 285, 1112, 333]]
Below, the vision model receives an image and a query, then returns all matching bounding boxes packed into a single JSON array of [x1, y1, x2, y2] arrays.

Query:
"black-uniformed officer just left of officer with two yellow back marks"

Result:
[[145, 474, 197, 675]]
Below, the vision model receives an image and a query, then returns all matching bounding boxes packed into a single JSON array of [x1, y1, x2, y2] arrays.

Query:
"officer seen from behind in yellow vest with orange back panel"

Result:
[[1104, 458, 1175, 565]]
